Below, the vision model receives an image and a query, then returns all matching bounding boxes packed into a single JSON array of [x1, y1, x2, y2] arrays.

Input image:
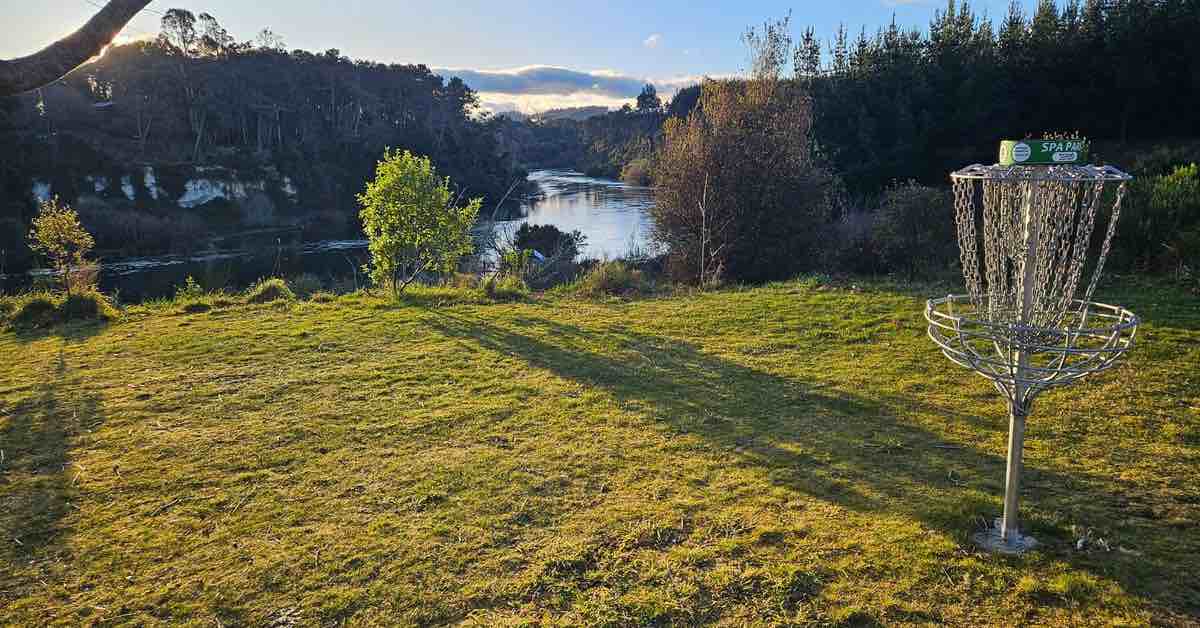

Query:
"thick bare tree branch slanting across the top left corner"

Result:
[[0, 0, 150, 96]]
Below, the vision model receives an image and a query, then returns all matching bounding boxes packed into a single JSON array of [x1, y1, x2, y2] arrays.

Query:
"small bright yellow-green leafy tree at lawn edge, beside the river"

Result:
[[358, 150, 484, 294]]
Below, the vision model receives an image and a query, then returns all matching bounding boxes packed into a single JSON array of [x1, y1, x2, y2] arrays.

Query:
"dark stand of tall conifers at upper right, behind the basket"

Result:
[[794, 0, 1200, 191]]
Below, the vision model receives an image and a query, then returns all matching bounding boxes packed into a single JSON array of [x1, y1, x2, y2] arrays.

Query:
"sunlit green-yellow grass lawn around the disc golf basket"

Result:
[[0, 281, 1200, 626]]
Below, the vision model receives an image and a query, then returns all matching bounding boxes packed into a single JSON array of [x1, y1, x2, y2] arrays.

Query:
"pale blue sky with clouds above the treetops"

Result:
[[0, 0, 1051, 113]]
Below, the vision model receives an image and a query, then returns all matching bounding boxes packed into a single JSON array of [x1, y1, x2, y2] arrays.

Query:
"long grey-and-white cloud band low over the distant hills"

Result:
[[433, 65, 700, 113]]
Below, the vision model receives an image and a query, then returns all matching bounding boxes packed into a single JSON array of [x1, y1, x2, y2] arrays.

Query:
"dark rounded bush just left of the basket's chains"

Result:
[[872, 181, 959, 274]]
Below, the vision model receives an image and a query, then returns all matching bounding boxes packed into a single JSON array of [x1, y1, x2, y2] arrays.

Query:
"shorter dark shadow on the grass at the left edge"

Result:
[[0, 351, 103, 573]]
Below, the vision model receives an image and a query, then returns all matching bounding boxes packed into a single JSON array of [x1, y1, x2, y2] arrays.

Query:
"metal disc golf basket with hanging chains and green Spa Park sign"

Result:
[[925, 140, 1139, 552]]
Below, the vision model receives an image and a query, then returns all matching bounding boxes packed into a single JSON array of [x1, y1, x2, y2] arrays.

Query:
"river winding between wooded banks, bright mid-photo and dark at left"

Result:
[[0, 171, 654, 303]]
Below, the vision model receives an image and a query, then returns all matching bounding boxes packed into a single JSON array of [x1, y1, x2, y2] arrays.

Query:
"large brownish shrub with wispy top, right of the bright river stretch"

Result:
[[650, 20, 832, 285]]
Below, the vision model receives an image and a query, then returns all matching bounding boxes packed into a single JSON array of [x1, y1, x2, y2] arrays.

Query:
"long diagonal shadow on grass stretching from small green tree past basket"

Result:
[[430, 312, 1195, 614]]
